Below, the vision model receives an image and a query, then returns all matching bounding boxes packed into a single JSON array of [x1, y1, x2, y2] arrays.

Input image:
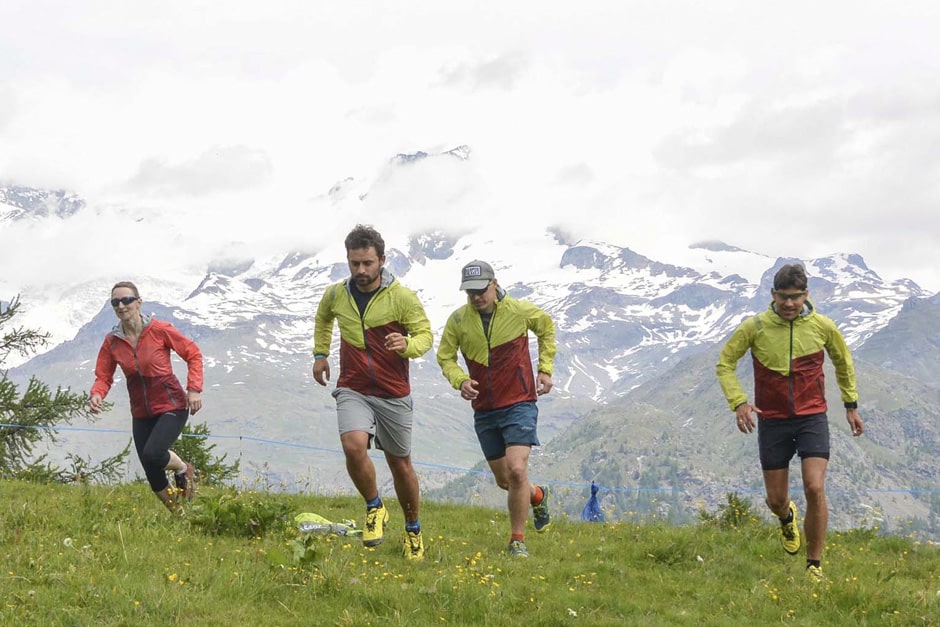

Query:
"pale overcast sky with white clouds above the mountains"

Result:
[[0, 0, 940, 291]]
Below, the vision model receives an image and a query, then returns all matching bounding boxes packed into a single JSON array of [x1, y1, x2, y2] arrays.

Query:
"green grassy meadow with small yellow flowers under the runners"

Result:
[[0, 482, 940, 627]]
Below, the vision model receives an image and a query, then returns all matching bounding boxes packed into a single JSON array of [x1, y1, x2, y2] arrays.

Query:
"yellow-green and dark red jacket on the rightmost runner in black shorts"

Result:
[[716, 301, 858, 418]]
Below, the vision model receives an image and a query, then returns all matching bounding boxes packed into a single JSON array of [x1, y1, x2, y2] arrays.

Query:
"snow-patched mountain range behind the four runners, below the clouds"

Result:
[[0, 164, 932, 536]]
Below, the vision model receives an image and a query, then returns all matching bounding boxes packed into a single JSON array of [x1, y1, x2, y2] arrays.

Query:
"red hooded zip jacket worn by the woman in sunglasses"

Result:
[[89, 316, 202, 418]]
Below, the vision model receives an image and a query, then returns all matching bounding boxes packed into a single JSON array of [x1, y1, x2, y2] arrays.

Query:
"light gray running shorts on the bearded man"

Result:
[[333, 388, 414, 457]]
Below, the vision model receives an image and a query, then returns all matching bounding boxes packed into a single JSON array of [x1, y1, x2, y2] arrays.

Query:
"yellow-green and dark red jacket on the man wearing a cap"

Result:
[[437, 290, 555, 411]]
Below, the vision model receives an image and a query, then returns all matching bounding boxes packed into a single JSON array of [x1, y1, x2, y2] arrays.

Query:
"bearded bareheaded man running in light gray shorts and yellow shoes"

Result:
[[313, 224, 434, 560]]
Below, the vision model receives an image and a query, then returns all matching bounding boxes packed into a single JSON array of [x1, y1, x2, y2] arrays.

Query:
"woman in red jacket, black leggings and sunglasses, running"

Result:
[[89, 281, 202, 512]]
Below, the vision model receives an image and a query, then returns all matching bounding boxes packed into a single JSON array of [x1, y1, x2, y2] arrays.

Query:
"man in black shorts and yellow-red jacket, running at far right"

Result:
[[717, 264, 865, 581]]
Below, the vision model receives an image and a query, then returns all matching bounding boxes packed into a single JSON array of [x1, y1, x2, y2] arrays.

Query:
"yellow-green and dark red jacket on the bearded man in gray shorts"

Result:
[[313, 268, 434, 398]]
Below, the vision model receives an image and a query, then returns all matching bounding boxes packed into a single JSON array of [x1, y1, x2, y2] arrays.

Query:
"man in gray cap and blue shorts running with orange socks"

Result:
[[437, 261, 555, 557]]
